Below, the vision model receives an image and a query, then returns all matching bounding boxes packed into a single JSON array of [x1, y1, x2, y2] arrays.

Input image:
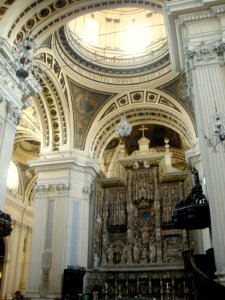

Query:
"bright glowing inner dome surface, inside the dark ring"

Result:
[[67, 8, 167, 68]]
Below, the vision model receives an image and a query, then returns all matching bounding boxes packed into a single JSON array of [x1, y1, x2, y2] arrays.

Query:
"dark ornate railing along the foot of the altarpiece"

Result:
[[84, 264, 193, 300]]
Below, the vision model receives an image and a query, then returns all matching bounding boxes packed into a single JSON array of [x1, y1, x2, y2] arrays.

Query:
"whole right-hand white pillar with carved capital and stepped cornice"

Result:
[[164, 0, 225, 282]]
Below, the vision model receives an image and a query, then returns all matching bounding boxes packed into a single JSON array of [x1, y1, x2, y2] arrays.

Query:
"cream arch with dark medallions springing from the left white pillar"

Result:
[[29, 51, 72, 151]]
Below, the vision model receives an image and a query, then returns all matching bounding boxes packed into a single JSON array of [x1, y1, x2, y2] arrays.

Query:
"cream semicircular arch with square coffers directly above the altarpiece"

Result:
[[86, 89, 196, 160]]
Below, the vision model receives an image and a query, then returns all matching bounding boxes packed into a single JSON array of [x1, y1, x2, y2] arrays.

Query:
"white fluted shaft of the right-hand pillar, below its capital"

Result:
[[191, 56, 225, 277]]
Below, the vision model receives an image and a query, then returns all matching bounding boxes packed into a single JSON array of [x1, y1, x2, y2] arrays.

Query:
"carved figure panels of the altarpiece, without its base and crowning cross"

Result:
[[95, 166, 185, 268]]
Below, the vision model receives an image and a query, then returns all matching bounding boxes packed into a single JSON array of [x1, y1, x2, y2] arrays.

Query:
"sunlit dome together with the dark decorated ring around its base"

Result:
[[57, 5, 172, 85]]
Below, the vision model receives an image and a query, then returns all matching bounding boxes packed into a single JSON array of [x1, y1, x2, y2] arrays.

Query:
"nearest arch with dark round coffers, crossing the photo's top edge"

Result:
[[4, 0, 163, 44]]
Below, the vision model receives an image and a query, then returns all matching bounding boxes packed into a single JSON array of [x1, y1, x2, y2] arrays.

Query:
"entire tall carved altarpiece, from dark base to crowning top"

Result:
[[86, 137, 192, 299]]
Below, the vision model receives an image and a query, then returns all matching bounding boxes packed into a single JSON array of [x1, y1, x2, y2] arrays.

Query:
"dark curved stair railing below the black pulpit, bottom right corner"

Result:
[[183, 250, 225, 300]]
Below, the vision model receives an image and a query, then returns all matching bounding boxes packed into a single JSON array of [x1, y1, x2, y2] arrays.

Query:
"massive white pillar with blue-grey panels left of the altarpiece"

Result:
[[26, 157, 97, 298]]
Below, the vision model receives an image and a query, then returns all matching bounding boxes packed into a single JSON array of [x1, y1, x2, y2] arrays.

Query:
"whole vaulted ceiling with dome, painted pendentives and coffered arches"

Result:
[[0, 0, 200, 176]]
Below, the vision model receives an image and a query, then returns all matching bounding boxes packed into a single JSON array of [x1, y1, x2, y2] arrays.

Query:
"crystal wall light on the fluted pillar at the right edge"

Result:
[[203, 107, 225, 152]]
